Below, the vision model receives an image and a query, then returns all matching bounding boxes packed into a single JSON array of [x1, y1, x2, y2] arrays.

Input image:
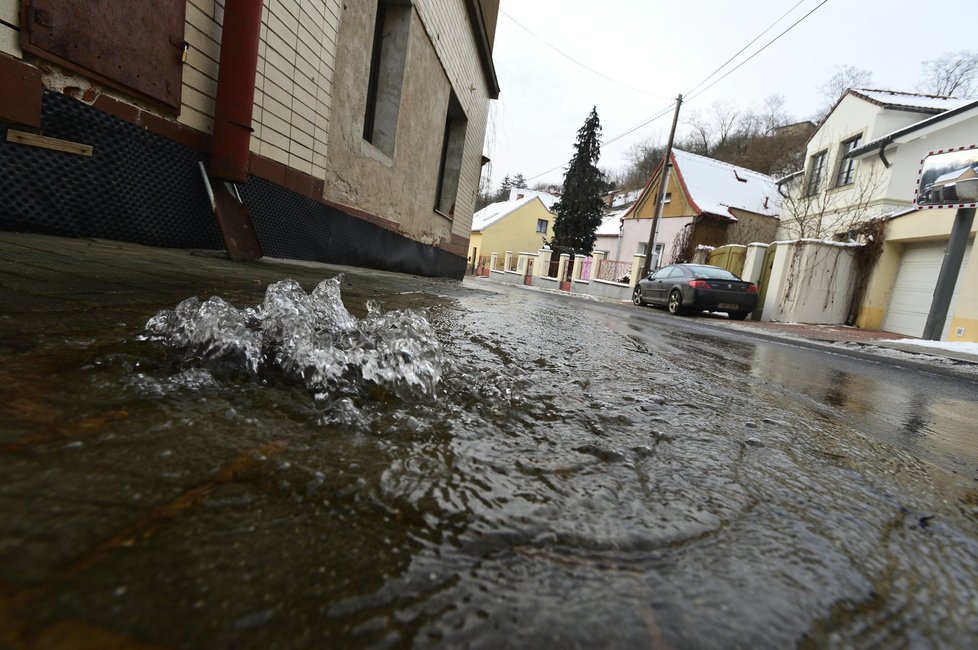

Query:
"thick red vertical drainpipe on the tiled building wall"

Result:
[[209, 0, 262, 183]]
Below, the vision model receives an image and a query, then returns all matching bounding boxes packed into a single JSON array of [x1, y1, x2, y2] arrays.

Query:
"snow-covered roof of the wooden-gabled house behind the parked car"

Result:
[[672, 149, 781, 217]]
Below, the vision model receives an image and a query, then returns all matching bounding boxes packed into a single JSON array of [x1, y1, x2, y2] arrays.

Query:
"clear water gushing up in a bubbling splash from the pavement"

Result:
[[145, 275, 444, 402]]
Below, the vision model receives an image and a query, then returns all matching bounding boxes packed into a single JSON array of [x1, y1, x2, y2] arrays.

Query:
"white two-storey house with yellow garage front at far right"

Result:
[[779, 89, 978, 341]]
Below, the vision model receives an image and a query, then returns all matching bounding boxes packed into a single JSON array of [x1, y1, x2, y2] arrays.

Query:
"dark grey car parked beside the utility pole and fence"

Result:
[[632, 264, 757, 320]]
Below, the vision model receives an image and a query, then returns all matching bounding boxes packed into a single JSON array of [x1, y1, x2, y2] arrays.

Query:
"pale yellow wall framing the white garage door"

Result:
[[856, 209, 978, 342]]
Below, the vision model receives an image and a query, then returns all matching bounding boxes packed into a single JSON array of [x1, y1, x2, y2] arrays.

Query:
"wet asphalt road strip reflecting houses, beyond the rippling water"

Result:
[[500, 280, 978, 481]]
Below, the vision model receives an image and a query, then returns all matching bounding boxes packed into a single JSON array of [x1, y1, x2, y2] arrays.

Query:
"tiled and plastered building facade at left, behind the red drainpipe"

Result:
[[0, 0, 499, 277]]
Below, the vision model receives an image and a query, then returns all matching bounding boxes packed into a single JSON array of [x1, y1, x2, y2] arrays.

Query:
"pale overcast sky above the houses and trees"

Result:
[[485, 0, 964, 187]]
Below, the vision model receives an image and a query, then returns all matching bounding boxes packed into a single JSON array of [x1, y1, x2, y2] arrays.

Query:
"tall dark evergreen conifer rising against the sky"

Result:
[[551, 107, 608, 254]]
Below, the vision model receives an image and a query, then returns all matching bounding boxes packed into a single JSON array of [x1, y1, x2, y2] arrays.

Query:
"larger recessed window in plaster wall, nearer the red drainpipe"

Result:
[[363, 0, 411, 156]]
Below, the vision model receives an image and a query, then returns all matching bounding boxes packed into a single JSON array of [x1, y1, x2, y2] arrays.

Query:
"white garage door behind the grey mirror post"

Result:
[[883, 241, 972, 338]]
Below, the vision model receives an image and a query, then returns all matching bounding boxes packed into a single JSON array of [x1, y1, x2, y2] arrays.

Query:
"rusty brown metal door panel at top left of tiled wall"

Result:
[[20, 0, 186, 109]]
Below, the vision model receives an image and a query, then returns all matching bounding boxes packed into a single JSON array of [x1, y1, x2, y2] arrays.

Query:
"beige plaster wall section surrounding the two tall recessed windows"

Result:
[[324, 0, 489, 243]]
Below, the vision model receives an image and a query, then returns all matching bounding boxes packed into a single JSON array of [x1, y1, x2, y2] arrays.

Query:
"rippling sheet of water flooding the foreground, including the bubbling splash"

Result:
[[0, 282, 978, 647]]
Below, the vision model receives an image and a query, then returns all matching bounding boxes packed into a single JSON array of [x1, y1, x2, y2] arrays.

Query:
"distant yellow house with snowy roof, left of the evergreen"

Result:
[[469, 196, 554, 269]]
